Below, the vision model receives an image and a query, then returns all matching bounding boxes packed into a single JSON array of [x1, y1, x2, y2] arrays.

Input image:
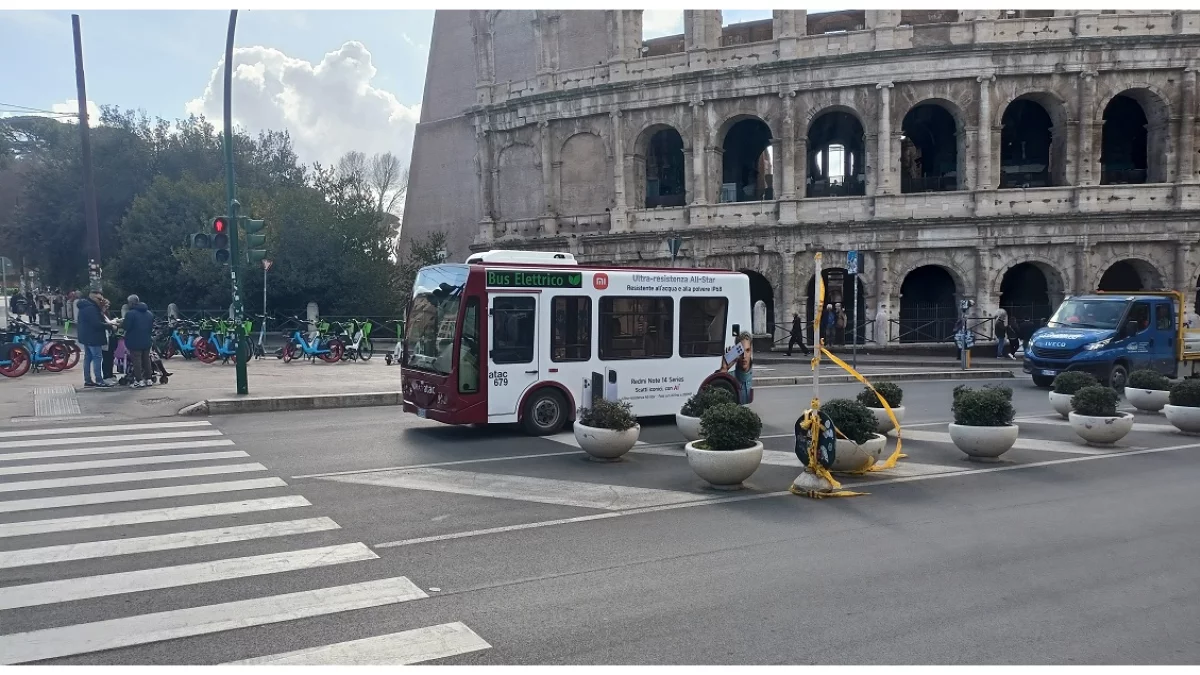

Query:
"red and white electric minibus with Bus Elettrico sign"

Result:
[[401, 251, 751, 436]]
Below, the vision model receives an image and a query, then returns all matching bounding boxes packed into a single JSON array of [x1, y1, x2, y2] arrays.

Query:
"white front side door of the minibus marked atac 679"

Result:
[[487, 294, 541, 417]]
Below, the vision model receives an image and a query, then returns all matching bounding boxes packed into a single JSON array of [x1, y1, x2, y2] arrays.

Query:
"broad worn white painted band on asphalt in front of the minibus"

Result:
[[325, 468, 712, 510]]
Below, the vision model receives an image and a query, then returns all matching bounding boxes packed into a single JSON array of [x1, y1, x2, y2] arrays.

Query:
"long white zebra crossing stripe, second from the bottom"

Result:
[[0, 577, 428, 664]]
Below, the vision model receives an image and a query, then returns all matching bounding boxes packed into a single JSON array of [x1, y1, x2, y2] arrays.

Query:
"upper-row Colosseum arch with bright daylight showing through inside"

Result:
[[804, 104, 868, 197]]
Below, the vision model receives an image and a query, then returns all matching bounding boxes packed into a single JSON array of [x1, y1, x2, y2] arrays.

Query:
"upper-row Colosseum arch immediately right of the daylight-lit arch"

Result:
[[896, 97, 967, 192]]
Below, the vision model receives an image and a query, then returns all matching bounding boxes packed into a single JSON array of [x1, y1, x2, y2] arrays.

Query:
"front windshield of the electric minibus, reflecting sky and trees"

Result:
[[404, 264, 469, 375]]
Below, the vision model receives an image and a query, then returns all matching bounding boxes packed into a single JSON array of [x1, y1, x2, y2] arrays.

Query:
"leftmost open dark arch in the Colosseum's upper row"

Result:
[[634, 121, 690, 209]]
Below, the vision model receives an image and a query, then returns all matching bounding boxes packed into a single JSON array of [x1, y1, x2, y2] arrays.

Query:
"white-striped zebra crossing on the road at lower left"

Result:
[[0, 420, 491, 665]]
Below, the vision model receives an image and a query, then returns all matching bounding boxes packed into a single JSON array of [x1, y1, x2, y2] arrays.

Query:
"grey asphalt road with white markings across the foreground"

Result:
[[0, 380, 1200, 664]]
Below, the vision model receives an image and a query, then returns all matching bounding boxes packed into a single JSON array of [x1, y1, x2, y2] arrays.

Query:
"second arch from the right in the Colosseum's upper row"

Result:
[[992, 89, 1070, 190]]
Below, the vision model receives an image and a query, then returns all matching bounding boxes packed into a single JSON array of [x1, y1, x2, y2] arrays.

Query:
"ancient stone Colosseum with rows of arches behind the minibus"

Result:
[[404, 10, 1200, 342]]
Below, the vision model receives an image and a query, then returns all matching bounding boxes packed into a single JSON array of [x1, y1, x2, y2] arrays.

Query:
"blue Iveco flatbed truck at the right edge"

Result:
[[1024, 291, 1200, 390]]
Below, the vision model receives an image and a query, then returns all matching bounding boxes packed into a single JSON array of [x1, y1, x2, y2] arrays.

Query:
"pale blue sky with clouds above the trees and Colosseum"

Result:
[[0, 10, 770, 163]]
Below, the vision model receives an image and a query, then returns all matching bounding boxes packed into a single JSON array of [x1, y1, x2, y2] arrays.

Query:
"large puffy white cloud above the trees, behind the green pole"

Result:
[[186, 41, 421, 165]]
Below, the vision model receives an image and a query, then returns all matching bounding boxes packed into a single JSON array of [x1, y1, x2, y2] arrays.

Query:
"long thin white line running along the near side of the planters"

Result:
[[373, 443, 1200, 549]]
